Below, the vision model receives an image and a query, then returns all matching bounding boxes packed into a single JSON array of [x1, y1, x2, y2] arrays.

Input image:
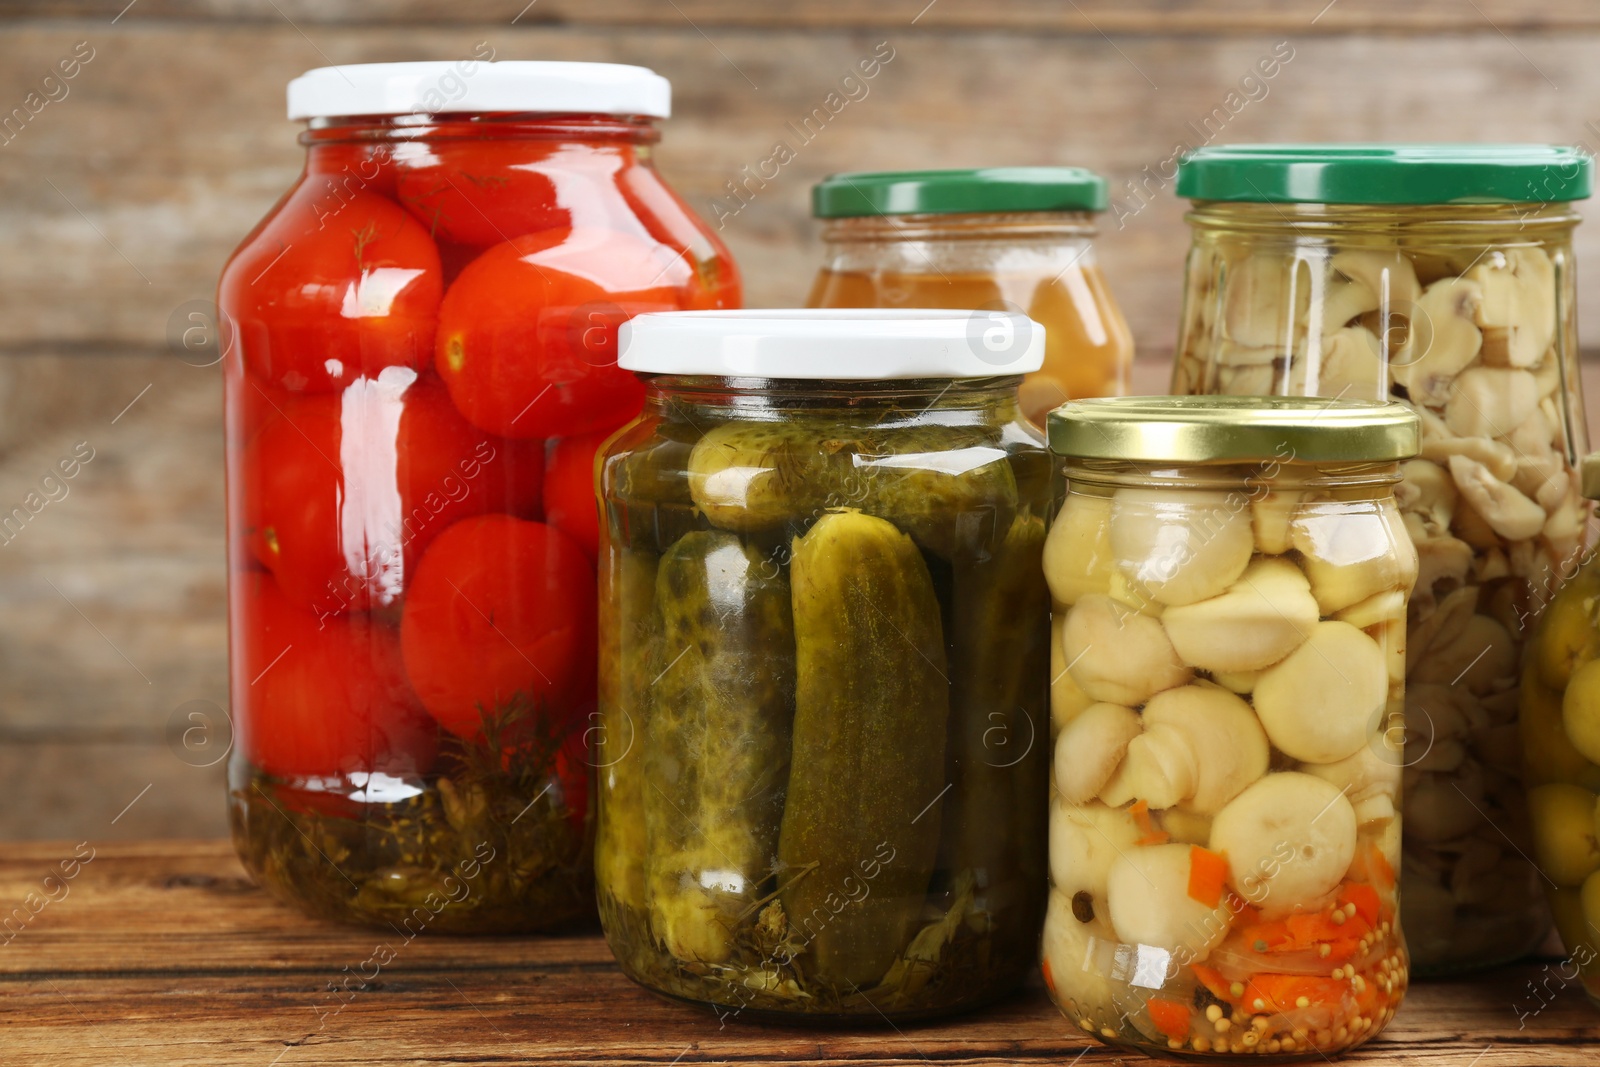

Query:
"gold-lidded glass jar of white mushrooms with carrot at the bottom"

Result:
[[1043, 397, 1418, 1056]]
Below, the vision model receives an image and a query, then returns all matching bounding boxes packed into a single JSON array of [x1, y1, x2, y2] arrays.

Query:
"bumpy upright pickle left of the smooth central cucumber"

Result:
[[645, 531, 795, 963]]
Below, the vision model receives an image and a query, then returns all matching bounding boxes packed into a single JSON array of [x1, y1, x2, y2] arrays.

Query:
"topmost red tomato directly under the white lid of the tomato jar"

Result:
[[397, 141, 566, 248]]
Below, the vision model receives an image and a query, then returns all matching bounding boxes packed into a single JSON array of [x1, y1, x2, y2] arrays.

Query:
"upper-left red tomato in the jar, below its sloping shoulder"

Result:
[[219, 185, 443, 392]]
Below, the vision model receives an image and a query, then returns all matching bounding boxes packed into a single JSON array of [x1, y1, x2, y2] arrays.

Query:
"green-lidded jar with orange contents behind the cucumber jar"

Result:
[[806, 166, 1133, 427]]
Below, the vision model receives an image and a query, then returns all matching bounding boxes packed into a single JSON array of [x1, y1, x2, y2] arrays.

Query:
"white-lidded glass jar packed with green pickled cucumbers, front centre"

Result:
[[595, 310, 1051, 1024]]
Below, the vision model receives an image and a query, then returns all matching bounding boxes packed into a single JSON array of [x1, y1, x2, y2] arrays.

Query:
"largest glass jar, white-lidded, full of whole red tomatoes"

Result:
[[218, 62, 739, 934]]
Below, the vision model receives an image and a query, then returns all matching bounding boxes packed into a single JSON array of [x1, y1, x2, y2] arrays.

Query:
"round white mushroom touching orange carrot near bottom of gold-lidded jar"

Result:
[[1106, 845, 1232, 963]]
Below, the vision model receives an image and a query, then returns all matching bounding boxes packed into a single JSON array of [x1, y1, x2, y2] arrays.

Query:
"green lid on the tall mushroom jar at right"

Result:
[[1178, 144, 1594, 203]]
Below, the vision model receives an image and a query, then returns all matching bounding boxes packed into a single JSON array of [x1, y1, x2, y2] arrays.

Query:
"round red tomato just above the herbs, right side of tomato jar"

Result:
[[400, 515, 595, 739]]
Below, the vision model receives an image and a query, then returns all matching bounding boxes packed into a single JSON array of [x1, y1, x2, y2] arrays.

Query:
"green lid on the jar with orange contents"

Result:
[[811, 166, 1107, 219]]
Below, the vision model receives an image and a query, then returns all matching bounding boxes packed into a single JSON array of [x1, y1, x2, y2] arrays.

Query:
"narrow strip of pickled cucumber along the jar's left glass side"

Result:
[[594, 547, 659, 909]]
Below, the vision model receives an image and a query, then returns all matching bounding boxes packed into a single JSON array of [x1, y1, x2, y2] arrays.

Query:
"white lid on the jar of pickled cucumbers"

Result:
[[618, 309, 1045, 381]]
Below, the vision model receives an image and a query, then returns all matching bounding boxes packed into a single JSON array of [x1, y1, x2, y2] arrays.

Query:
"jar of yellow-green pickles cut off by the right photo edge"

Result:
[[1518, 454, 1600, 1005]]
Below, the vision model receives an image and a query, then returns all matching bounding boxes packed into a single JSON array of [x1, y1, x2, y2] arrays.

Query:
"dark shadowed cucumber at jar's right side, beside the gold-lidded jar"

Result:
[[939, 515, 1050, 931]]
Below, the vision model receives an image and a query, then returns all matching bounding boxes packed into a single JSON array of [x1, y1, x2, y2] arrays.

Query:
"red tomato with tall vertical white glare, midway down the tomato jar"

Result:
[[243, 368, 542, 613]]
